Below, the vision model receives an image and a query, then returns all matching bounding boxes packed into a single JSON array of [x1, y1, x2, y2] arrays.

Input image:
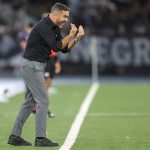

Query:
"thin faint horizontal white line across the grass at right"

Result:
[[87, 112, 150, 117]]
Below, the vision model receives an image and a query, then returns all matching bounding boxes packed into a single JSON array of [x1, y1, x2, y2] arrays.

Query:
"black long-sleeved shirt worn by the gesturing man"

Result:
[[24, 16, 68, 63]]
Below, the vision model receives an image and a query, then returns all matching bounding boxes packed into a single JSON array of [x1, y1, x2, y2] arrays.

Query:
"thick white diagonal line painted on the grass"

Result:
[[59, 83, 99, 150]]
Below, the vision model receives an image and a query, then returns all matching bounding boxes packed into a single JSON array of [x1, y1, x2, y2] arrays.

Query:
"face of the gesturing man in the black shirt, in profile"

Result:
[[56, 10, 69, 28]]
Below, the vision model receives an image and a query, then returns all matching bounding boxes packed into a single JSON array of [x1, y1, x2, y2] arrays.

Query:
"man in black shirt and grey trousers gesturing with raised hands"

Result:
[[8, 3, 84, 147]]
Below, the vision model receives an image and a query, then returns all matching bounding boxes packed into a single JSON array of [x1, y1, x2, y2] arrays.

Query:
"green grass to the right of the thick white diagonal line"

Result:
[[72, 84, 150, 150]]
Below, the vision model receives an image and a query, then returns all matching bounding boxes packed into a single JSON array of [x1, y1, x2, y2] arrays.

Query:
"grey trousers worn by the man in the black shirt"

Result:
[[12, 59, 49, 137]]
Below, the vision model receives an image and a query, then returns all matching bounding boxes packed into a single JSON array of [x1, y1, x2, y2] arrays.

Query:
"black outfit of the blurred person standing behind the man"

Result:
[[45, 56, 58, 79]]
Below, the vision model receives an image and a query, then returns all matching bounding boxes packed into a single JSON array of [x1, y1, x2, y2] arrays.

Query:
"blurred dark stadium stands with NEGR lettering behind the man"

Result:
[[0, 0, 150, 78]]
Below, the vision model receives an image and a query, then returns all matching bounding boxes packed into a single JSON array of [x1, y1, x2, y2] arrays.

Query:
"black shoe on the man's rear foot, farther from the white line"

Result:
[[7, 135, 32, 146]]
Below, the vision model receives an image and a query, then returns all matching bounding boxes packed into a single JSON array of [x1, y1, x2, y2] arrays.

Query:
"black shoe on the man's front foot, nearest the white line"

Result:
[[35, 137, 59, 147]]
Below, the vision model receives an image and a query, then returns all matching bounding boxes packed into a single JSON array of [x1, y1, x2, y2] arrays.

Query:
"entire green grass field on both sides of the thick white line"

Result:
[[0, 83, 150, 150]]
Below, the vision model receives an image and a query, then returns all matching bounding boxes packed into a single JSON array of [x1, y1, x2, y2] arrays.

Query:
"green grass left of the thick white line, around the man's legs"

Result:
[[0, 85, 90, 150]]
